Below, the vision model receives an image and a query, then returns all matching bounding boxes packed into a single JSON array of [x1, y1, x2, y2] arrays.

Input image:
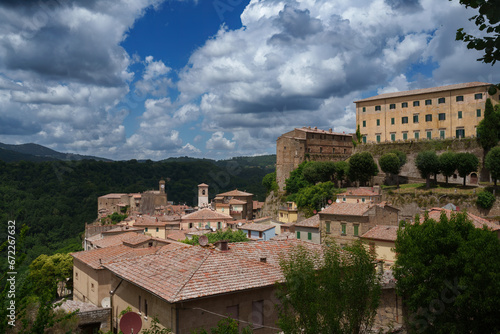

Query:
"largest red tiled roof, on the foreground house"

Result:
[[105, 240, 321, 303]]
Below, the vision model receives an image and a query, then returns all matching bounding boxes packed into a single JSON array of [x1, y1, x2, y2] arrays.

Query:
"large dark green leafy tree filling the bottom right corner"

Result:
[[393, 212, 500, 333]]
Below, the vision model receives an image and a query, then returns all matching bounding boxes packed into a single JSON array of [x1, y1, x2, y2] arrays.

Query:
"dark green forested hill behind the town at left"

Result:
[[0, 159, 274, 269]]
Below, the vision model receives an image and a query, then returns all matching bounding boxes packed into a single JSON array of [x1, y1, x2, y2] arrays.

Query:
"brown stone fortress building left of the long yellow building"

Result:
[[276, 127, 353, 190]]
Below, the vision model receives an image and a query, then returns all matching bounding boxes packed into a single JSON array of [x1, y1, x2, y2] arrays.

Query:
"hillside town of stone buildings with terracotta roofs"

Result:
[[57, 82, 500, 333]]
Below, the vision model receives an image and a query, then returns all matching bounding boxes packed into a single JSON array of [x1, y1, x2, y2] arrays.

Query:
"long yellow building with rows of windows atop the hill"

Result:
[[354, 82, 499, 143]]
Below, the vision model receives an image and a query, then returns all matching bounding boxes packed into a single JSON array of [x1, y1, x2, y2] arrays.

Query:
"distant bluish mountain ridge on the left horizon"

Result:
[[0, 143, 112, 162]]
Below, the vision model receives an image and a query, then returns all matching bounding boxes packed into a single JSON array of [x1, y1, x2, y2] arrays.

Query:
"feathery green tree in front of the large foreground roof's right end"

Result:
[[276, 242, 381, 334]]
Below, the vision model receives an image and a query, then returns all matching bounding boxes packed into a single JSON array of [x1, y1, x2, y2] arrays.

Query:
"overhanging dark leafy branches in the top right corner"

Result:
[[450, 0, 500, 65]]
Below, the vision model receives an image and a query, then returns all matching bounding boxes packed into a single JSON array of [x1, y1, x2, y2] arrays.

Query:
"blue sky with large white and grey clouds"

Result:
[[0, 0, 500, 161]]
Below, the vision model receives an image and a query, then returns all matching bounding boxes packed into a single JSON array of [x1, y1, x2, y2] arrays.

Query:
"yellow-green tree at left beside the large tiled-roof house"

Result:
[[29, 254, 73, 296]]
